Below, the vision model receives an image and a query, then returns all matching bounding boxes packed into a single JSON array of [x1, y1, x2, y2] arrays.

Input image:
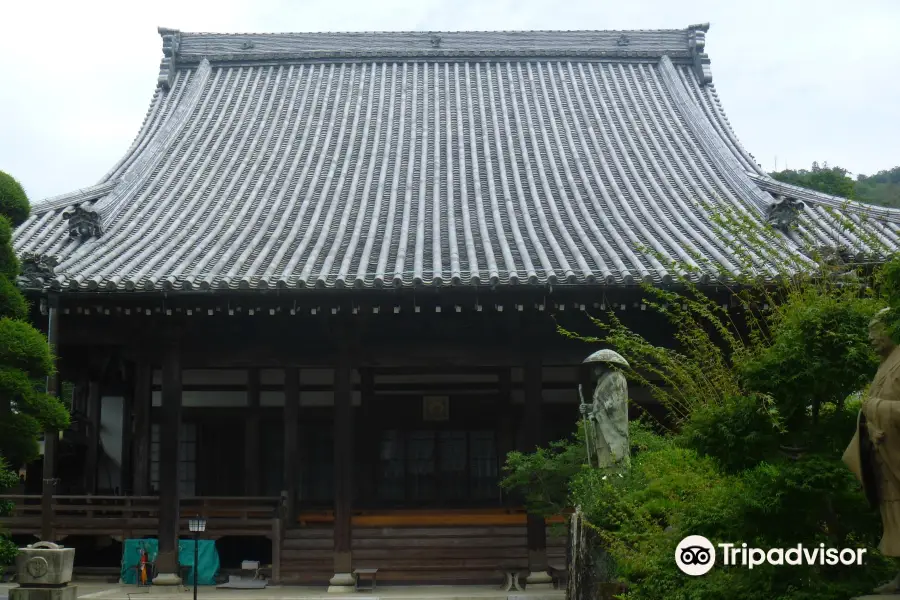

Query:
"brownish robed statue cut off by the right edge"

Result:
[[843, 309, 900, 594]]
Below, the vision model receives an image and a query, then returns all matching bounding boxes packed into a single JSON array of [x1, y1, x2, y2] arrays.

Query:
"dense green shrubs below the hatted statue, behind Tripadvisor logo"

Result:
[[571, 418, 895, 600]]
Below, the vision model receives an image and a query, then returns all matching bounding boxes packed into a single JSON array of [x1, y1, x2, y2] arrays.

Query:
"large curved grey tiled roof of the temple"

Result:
[[15, 26, 900, 290]]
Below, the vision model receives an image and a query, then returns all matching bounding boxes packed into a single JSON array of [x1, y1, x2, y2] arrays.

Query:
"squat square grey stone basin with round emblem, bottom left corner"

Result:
[[9, 542, 78, 600]]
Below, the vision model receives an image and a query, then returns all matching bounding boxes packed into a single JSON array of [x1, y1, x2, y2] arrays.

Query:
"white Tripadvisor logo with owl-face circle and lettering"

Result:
[[675, 535, 866, 576]]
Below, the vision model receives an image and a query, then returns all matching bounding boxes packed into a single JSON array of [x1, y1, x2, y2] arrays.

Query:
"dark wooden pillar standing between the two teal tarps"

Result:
[[153, 343, 181, 585]]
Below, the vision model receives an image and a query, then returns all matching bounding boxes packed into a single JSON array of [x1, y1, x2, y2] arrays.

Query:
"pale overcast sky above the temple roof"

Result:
[[0, 0, 900, 201]]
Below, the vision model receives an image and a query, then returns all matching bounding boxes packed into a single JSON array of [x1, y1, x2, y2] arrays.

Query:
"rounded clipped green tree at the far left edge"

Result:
[[0, 171, 69, 560]]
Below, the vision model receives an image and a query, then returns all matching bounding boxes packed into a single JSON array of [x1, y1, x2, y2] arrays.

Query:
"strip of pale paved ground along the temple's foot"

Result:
[[0, 582, 564, 600]]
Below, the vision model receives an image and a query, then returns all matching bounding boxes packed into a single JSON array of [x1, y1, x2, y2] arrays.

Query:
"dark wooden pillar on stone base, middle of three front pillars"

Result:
[[328, 352, 354, 592]]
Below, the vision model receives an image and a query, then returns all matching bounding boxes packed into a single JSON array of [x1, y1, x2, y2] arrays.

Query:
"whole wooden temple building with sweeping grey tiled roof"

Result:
[[7, 25, 900, 590]]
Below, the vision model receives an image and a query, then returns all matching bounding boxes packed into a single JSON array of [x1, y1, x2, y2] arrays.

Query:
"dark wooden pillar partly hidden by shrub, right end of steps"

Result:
[[523, 355, 553, 589]]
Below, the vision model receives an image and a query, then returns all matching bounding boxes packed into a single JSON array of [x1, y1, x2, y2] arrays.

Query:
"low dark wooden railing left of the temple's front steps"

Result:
[[0, 495, 281, 539]]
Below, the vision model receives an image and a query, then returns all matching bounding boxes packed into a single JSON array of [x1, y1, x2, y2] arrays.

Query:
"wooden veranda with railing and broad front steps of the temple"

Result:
[[0, 495, 565, 584]]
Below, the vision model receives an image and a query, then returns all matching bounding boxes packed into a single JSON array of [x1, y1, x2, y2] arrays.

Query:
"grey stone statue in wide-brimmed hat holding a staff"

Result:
[[578, 350, 631, 470]]
